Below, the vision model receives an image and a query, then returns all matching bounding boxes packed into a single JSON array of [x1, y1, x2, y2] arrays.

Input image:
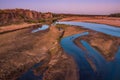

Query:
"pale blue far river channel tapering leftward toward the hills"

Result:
[[56, 21, 120, 37]]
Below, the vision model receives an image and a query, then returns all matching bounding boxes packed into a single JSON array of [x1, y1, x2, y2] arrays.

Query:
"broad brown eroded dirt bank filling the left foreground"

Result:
[[0, 26, 78, 80]]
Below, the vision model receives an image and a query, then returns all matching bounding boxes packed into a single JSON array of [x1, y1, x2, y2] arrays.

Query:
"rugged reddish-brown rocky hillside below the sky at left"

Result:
[[0, 9, 53, 25]]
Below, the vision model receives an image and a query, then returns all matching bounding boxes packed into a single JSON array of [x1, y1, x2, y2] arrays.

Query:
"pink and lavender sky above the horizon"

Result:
[[0, 0, 120, 14]]
